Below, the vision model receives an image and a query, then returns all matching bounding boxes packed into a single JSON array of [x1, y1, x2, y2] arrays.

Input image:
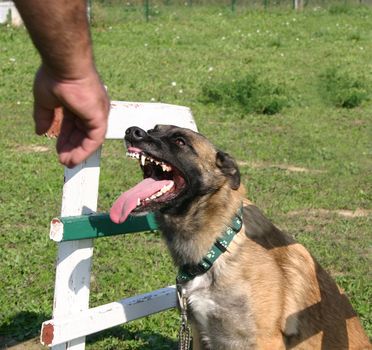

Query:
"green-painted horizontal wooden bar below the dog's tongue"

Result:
[[59, 213, 158, 241]]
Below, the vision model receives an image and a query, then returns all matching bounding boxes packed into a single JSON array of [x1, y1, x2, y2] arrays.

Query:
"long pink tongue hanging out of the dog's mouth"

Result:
[[110, 177, 172, 224]]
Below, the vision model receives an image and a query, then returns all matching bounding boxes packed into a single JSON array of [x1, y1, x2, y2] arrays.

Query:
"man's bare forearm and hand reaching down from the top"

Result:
[[15, 0, 109, 167]]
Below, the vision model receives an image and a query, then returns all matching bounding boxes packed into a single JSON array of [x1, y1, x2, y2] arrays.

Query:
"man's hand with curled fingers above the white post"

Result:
[[34, 65, 110, 167]]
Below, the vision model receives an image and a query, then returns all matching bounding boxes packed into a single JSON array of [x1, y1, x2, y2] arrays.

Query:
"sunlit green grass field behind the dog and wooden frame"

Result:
[[0, 3, 372, 350]]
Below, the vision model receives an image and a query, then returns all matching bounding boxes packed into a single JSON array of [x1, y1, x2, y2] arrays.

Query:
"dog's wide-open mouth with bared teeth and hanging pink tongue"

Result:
[[110, 147, 186, 223]]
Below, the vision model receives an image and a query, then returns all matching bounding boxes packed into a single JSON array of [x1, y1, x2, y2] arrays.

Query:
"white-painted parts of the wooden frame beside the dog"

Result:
[[40, 101, 197, 350]]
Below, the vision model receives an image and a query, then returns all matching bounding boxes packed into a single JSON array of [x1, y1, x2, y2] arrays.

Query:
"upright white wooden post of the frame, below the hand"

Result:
[[53, 149, 101, 350]]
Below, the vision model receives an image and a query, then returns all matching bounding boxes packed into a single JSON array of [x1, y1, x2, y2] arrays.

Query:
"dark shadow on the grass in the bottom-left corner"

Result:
[[0, 311, 50, 349]]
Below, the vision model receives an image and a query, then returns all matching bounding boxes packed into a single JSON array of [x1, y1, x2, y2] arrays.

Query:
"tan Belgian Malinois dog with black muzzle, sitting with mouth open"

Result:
[[110, 125, 372, 350]]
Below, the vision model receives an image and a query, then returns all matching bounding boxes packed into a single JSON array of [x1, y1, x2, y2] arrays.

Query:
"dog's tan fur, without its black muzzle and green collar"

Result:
[[124, 126, 372, 350]]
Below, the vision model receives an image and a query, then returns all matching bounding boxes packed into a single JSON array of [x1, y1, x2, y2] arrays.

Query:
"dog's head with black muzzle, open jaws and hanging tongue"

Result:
[[110, 125, 240, 223]]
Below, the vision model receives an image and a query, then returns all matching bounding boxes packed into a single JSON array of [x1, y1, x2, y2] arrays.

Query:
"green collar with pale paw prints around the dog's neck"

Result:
[[177, 207, 243, 284]]
